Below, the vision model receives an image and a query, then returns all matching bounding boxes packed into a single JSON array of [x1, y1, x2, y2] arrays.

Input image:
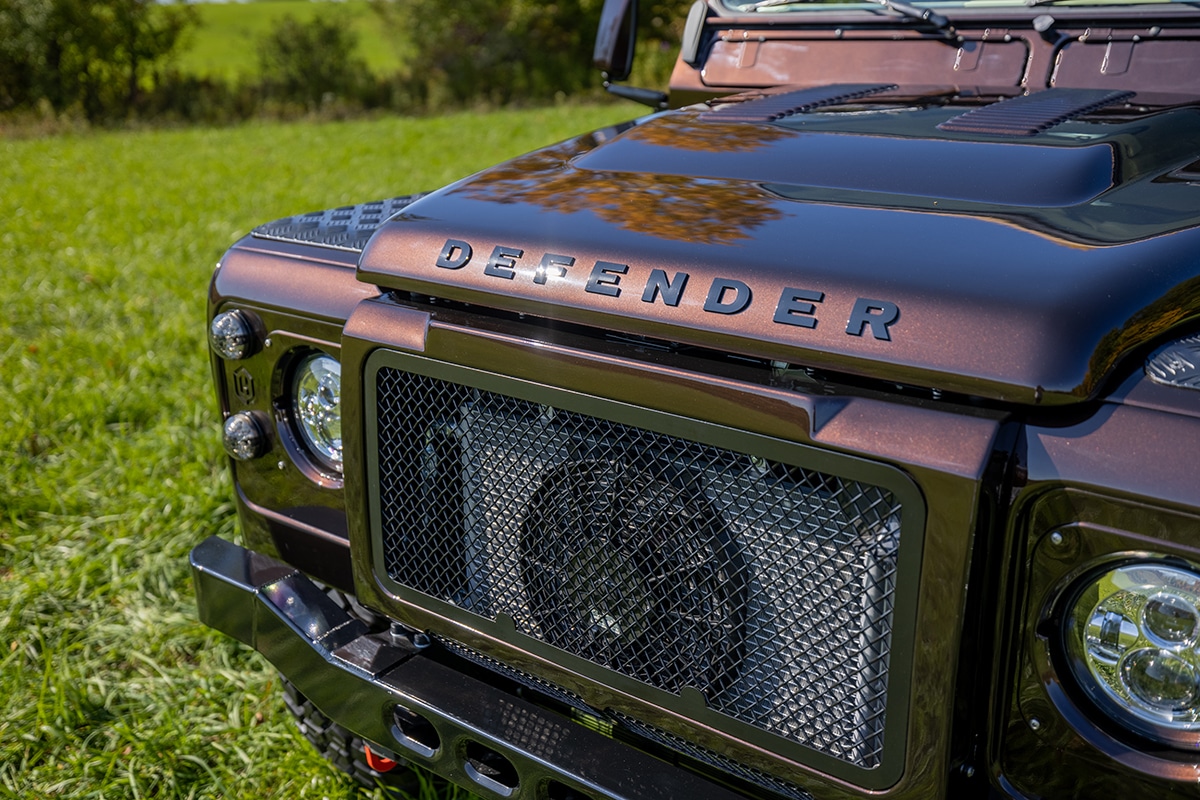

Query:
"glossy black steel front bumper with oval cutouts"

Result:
[[191, 536, 740, 800]]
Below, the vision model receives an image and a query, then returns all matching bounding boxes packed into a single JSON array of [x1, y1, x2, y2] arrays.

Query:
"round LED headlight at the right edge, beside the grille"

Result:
[[1063, 563, 1200, 747]]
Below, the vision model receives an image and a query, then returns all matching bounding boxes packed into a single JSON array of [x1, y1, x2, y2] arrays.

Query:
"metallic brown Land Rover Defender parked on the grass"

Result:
[[192, 0, 1200, 800]]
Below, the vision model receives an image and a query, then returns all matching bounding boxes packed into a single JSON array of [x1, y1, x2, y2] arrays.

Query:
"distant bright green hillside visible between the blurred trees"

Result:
[[179, 0, 402, 80]]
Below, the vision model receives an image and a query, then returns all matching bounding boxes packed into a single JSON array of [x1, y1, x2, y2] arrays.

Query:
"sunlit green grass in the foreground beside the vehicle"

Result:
[[0, 106, 636, 799]]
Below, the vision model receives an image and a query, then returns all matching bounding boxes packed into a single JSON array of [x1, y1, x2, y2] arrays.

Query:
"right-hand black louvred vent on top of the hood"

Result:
[[937, 89, 1134, 136]]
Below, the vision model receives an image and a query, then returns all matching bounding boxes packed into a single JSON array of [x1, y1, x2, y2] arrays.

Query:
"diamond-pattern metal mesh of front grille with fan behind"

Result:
[[376, 367, 900, 768]]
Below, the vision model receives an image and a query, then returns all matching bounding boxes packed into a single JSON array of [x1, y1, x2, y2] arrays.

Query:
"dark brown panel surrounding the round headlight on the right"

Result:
[[1017, 506, 1200, 782]]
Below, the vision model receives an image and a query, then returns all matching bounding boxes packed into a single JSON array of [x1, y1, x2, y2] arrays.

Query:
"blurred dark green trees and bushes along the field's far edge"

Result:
[[0, 0, 690, 122]]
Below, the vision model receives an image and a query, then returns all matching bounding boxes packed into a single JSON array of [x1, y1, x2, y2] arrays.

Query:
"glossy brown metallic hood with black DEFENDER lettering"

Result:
[[359, 94, 1200, 403]]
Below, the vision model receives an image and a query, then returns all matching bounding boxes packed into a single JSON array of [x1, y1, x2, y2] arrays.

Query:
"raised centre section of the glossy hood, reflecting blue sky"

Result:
[[571, 116, 1116, 209]]
